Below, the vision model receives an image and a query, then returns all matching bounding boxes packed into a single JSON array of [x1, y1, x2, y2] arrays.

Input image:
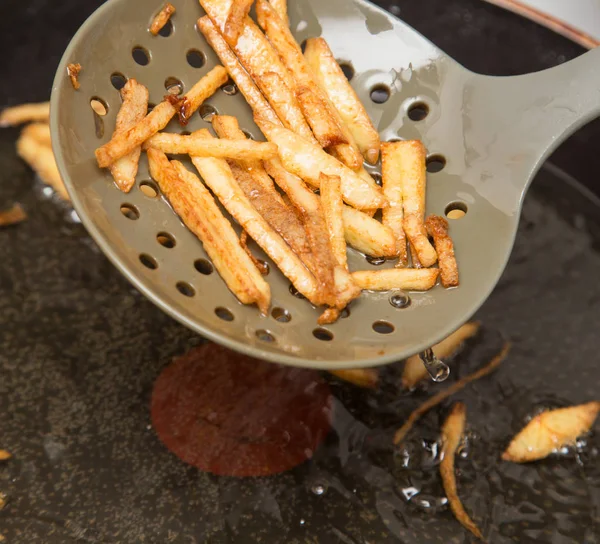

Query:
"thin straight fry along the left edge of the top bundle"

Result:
[[197, 16, 282, 125]]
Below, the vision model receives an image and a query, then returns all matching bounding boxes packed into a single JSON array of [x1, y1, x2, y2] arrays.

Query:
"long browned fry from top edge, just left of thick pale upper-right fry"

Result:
[[256, 0, 362, 159]]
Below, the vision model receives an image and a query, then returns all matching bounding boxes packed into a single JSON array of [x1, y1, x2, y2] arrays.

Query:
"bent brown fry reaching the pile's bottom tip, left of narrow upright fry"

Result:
[[265, 159, 360, 310]]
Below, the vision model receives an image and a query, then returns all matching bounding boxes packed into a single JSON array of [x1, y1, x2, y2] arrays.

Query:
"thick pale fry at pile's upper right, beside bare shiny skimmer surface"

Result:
[[304, 38, 380, 164]]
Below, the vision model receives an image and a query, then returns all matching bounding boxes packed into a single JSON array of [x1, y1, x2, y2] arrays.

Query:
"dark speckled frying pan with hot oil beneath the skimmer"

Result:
[[0, 0, 600, 544]]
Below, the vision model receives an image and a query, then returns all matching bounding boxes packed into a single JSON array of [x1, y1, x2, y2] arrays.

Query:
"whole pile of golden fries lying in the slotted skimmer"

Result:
[[90, 0, 458, 324]]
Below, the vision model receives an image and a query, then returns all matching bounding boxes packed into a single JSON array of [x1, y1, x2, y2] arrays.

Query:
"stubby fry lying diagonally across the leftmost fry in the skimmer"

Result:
[[96, 101, 176, 168]]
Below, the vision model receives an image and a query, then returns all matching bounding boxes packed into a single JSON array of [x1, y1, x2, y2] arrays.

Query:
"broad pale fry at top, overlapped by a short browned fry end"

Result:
[[200, 0, 313, 139]]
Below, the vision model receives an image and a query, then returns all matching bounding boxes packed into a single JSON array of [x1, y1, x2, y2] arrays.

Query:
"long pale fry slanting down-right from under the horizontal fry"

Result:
[[192, 130, 320, 304]]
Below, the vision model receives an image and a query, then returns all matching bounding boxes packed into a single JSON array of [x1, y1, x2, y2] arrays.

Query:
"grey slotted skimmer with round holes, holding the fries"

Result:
[[51, 0, 600, 369]]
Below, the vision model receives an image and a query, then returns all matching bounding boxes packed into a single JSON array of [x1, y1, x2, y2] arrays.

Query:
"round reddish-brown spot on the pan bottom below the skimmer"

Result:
[[152, 344, 331, 477]]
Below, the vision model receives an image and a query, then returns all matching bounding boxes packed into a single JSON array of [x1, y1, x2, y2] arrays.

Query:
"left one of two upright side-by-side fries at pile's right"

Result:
[[381, 142, 408, 268]]
